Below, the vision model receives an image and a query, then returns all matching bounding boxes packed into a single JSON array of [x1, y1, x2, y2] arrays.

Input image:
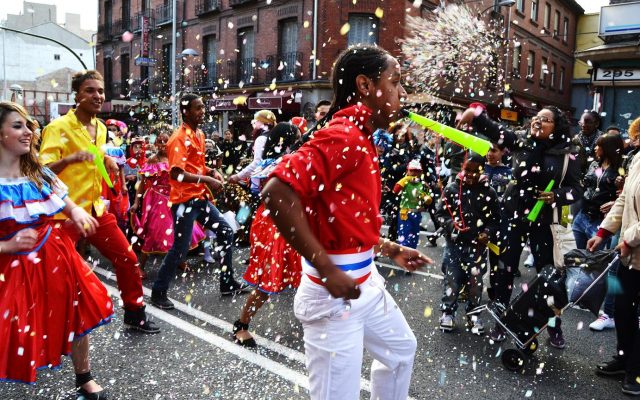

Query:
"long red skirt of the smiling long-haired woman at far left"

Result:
[[0, 221, 113, 383]]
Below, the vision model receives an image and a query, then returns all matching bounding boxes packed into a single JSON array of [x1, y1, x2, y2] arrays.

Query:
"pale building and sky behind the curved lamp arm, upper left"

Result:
[[0, 2, 95, 124]]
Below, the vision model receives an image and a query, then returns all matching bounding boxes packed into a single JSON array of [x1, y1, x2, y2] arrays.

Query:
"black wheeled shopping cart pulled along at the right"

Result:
[[467, 250, 619, 372]]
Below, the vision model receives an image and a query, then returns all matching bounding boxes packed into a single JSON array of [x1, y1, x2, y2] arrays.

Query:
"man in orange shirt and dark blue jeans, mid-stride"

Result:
[[151, 93, 247, 310]]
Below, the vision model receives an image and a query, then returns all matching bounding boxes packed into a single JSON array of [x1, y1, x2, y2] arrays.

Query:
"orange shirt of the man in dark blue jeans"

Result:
[[167, 123, 207, 204]]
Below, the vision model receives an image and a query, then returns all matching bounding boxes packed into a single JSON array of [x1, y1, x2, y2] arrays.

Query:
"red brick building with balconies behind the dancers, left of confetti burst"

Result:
[[97, 0, 437, 133]]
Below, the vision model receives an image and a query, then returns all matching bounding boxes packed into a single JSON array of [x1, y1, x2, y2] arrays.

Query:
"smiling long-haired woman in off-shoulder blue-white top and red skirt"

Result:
[[0, 102, 113, 400]]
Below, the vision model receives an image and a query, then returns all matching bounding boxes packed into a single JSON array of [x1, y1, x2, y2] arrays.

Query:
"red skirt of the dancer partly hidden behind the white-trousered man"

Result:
[[243, 205, 302, 294]]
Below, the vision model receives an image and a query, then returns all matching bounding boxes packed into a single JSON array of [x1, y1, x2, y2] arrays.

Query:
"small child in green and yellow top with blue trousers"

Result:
[[393, 160, 431, 249]]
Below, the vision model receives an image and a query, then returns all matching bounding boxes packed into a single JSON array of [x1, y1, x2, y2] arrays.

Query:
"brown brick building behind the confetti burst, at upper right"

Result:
[[461, 0, 584, 123]]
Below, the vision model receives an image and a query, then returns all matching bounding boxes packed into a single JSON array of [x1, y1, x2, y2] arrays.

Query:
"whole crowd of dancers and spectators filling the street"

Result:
[[0, 46, 640, 399]]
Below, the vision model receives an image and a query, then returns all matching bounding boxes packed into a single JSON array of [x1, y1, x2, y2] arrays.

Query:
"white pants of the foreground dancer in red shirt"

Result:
[[294, 267, 416, 400]]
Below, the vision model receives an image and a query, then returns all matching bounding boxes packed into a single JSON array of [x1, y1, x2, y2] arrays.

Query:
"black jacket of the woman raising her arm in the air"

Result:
[[473, 113, 582, 224]]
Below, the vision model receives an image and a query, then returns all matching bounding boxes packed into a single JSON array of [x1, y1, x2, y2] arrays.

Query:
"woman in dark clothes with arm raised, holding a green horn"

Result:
[[460, 106, 582, 348]]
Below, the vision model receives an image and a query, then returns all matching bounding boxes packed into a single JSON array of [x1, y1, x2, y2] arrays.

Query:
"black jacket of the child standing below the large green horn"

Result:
[[436, 176, 500, 243]]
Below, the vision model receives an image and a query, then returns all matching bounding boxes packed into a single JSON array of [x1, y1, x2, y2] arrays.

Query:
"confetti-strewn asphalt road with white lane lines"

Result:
[[0, 231, 624, 400]]
